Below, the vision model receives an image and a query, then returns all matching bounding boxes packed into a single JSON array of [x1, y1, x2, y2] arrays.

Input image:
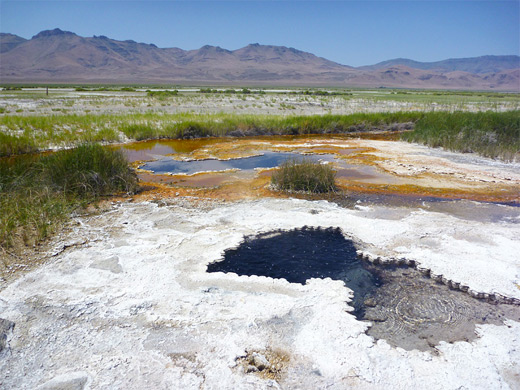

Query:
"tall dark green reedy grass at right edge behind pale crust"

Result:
[[402, 111, 520, 161]]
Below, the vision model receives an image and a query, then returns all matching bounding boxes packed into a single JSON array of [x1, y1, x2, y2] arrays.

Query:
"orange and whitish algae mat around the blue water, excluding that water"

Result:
[[120, 135, 520, 203]]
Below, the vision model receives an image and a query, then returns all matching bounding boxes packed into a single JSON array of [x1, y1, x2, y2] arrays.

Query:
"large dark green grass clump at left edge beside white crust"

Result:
[[0, 144, 137, 249]]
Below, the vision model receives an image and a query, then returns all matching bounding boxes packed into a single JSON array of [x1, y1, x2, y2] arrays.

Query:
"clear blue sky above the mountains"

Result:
[[0, 0, 520, 66]]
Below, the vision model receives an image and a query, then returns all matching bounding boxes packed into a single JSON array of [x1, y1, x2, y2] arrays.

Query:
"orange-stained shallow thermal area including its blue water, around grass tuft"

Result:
[[117, 136, 520, 216]]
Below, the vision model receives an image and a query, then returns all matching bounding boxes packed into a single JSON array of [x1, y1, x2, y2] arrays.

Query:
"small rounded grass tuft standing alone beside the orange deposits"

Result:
[[271, 160, 336, 193]]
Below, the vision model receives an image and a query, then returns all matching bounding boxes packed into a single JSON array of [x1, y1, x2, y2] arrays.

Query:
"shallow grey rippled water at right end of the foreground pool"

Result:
[[361, 265, 520, 350]]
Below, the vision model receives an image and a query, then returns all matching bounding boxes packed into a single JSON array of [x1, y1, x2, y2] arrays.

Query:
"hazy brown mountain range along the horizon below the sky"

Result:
[[0, 29, 520, 92]]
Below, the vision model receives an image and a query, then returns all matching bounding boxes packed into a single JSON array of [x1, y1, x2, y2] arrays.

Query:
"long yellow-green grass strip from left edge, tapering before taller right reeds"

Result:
[[0, 112, 421, 156]]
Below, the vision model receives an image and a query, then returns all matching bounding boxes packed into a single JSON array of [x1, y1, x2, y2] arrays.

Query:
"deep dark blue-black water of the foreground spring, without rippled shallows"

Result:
[[207, 227, 380, 314]]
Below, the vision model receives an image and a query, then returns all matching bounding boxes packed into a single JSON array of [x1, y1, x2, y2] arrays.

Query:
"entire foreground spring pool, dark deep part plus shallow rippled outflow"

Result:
[[207, 227, 520, 352]]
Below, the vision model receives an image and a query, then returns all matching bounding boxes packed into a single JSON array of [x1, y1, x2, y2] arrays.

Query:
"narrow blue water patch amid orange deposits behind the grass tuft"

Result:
[[141, 151, 334, 175]]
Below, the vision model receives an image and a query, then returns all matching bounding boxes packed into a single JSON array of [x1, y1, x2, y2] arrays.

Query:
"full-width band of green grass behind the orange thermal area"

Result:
[[0, 110, 520, 161]]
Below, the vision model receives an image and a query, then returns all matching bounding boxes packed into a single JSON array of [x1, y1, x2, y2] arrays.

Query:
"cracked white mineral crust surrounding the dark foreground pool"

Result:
[[0, 199, 520, 389]]
